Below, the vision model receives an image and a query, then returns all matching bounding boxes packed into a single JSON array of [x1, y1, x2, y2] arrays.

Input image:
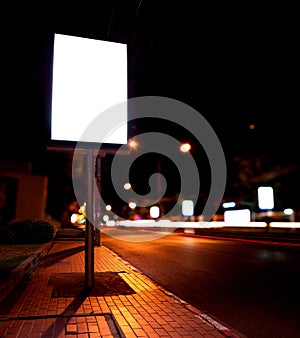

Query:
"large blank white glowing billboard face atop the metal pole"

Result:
[[51, 34, 128, 144]]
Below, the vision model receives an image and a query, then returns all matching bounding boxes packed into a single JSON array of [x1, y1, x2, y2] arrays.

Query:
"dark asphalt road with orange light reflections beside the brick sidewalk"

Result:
[[101, 229, 300, 338]]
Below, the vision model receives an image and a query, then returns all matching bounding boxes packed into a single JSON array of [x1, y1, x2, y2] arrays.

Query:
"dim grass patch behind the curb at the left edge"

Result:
[[0, 244, 43, 283]]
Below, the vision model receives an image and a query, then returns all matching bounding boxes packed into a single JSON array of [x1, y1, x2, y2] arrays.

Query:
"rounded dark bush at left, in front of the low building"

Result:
[[7, 219, 54, 244]]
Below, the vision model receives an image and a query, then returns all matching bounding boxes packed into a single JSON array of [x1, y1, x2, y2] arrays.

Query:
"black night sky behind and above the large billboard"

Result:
[[0, 0, 300, 211]]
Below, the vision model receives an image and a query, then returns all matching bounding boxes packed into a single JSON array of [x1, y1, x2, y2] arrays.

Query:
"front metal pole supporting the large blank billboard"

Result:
[[85, 149, 94, 291]]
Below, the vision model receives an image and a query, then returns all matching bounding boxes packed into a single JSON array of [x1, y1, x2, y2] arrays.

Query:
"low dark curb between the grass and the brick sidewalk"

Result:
[[0, 241, 53, 303]]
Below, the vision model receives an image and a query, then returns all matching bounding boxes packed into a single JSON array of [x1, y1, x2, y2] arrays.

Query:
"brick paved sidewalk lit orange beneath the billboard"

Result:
[[0, 241, 237, 338]]
